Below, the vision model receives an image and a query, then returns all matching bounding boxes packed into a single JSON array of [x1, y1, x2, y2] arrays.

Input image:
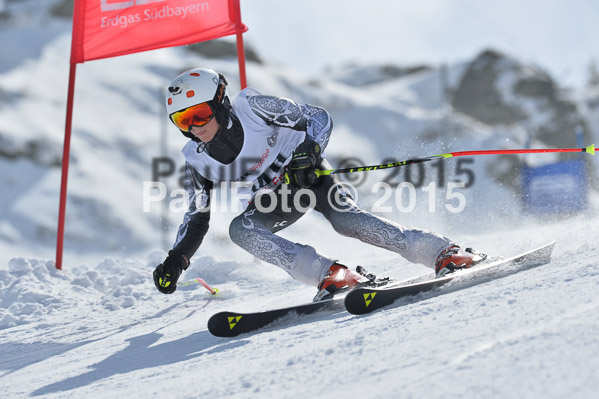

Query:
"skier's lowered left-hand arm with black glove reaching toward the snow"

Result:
[[154, 164, 212, 294]]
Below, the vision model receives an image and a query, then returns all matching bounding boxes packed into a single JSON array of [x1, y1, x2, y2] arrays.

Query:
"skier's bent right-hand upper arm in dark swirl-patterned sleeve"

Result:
[[248, 95, 333, 151]]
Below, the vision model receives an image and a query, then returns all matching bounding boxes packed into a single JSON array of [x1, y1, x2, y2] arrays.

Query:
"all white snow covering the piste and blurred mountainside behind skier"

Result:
[[0, 1, 599, 398]]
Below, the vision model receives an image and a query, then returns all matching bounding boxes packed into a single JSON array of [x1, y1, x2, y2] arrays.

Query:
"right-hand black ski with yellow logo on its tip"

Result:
[[344, 242, 555, 315]]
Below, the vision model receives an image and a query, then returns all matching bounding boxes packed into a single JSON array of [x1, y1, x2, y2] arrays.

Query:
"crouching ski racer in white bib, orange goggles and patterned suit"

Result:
[[153, 68, 483, 301]]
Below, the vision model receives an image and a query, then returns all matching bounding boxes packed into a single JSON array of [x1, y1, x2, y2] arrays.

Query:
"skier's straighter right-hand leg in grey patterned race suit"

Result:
[[314, 161, 453, 268]]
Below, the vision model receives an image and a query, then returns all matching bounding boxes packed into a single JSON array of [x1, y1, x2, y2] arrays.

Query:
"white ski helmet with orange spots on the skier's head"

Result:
[[166, 68, 230, 138]]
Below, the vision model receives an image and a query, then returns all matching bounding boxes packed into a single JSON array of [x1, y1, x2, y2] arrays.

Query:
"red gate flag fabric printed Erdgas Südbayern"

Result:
[[71, 0, 247, 63]]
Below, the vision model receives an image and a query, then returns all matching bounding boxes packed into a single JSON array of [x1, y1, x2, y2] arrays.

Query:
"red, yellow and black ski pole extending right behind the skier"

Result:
[[284, 144, 595, 184]]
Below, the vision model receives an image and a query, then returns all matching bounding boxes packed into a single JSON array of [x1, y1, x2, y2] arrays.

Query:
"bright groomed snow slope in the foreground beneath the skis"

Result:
[[0, 218, 599, 398]]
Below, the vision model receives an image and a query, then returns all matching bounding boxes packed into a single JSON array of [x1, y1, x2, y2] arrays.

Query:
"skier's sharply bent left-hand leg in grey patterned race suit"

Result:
[[229, 186, 335, 286]]
